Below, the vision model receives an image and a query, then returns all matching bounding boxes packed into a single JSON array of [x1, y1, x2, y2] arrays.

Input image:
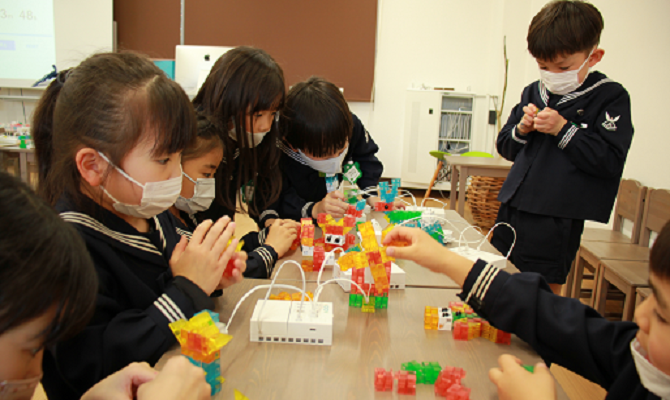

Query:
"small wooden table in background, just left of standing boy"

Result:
[[444, 156, 514, 216]]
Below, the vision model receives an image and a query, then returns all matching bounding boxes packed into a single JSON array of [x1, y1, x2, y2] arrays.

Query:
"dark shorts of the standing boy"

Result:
[[491, 204, 584, 284]]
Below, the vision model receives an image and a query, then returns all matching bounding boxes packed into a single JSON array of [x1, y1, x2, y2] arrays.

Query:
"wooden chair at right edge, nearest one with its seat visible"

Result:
[[580, 189, 670, 321]]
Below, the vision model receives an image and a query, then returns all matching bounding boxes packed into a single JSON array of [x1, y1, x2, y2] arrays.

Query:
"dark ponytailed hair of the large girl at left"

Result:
[[32, 53, 196, 206]]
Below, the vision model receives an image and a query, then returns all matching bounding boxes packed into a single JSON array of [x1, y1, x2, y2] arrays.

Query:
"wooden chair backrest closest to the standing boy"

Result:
[[613, 179, 647, 244]]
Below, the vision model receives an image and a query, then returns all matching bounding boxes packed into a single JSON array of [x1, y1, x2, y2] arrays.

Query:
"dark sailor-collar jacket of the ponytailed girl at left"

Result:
[[42, 200, 214, 400]]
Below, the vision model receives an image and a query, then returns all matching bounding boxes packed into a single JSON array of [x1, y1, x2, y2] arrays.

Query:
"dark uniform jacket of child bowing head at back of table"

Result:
[[261, 114, 384, 221]]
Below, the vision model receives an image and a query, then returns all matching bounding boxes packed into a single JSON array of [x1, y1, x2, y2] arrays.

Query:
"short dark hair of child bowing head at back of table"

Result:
[[279, 76, 354, 157]]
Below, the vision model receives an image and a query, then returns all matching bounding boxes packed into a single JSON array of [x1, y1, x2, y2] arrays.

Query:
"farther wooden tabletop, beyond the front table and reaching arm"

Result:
[[275, 210, 519, 289]]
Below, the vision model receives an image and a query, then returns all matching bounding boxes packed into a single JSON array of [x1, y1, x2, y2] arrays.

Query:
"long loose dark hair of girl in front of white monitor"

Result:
[[193, 46, 286, 216]]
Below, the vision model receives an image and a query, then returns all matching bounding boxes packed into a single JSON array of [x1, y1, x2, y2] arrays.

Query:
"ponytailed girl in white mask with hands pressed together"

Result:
[[33, 53, 246, 399]]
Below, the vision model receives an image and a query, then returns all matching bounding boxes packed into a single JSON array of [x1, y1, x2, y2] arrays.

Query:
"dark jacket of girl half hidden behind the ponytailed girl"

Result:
[[175, 209, 279, 279]]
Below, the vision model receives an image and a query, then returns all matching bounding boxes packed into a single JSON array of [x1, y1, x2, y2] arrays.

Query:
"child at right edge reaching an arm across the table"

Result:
[[384, 222, 670, 400]]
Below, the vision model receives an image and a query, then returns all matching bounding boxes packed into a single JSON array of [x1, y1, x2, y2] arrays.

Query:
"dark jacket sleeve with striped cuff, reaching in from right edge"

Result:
[[459, 260, 658, 400]]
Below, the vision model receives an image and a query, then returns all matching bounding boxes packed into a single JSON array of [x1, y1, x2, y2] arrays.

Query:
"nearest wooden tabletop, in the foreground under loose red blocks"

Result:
[[158, 279, 568, 400]]
